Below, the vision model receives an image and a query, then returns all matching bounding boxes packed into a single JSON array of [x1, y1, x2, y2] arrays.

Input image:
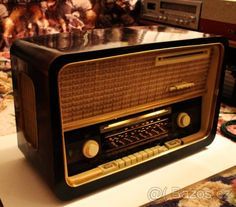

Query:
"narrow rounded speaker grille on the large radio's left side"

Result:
[[20, 73, 38, 148]]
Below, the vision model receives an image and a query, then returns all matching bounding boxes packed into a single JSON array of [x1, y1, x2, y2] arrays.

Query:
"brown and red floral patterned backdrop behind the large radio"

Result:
[[0, 0, 140, 114]]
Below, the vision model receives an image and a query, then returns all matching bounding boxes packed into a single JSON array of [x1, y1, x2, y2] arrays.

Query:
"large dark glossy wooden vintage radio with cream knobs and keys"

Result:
[[11, 26, 226, 199]]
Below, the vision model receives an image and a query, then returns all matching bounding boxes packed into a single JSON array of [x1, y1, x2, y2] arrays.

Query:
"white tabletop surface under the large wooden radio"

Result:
[[0, 134, 236, 207]]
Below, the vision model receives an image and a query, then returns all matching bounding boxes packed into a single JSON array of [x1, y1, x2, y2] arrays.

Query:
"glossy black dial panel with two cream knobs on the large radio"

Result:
[[64, 98, 202, 179]]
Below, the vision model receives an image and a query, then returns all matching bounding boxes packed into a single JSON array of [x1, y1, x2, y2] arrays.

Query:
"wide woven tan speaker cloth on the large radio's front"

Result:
[[58, 49, 211, 128]]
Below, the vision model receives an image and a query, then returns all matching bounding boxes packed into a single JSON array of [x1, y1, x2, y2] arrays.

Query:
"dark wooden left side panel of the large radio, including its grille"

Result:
[[11, 55, 59, 185]]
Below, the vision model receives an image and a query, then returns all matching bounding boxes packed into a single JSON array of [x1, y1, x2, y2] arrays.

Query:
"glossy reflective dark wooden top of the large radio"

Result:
[[12, 25, 218, 54]]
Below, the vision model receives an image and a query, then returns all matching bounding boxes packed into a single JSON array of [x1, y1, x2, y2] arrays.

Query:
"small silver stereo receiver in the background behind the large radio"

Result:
[[141, 0, 202, 30]]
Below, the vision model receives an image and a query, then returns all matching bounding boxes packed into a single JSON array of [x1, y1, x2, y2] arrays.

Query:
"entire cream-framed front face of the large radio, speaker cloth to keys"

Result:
[[58, 45, 221, 187]]
